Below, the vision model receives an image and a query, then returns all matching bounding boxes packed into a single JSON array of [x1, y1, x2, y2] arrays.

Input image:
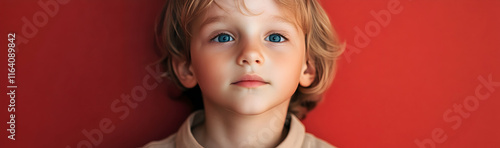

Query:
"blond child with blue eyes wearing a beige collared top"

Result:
[[145, 0, 342, 148]]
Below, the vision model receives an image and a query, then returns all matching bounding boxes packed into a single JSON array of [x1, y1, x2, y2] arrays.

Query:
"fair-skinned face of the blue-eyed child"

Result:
[[182, 0, 312, 114]]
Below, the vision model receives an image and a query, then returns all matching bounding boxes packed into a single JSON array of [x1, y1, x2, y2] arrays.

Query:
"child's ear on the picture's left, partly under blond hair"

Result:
[[172, 59, 198, 88]]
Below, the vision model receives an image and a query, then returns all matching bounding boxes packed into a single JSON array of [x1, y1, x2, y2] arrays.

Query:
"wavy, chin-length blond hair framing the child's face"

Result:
[[155, 0, 343, 119]]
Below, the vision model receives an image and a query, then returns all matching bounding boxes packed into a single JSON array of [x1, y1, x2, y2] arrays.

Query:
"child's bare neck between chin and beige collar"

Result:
[[193, 98, 289, 147]]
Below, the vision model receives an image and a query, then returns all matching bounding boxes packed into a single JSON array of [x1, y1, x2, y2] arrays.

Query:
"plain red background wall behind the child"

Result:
[[0, 0, 500, 148]]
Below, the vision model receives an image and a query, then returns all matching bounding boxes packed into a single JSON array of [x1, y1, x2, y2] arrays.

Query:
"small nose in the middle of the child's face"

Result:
[[236, 40, 265, 66]]
